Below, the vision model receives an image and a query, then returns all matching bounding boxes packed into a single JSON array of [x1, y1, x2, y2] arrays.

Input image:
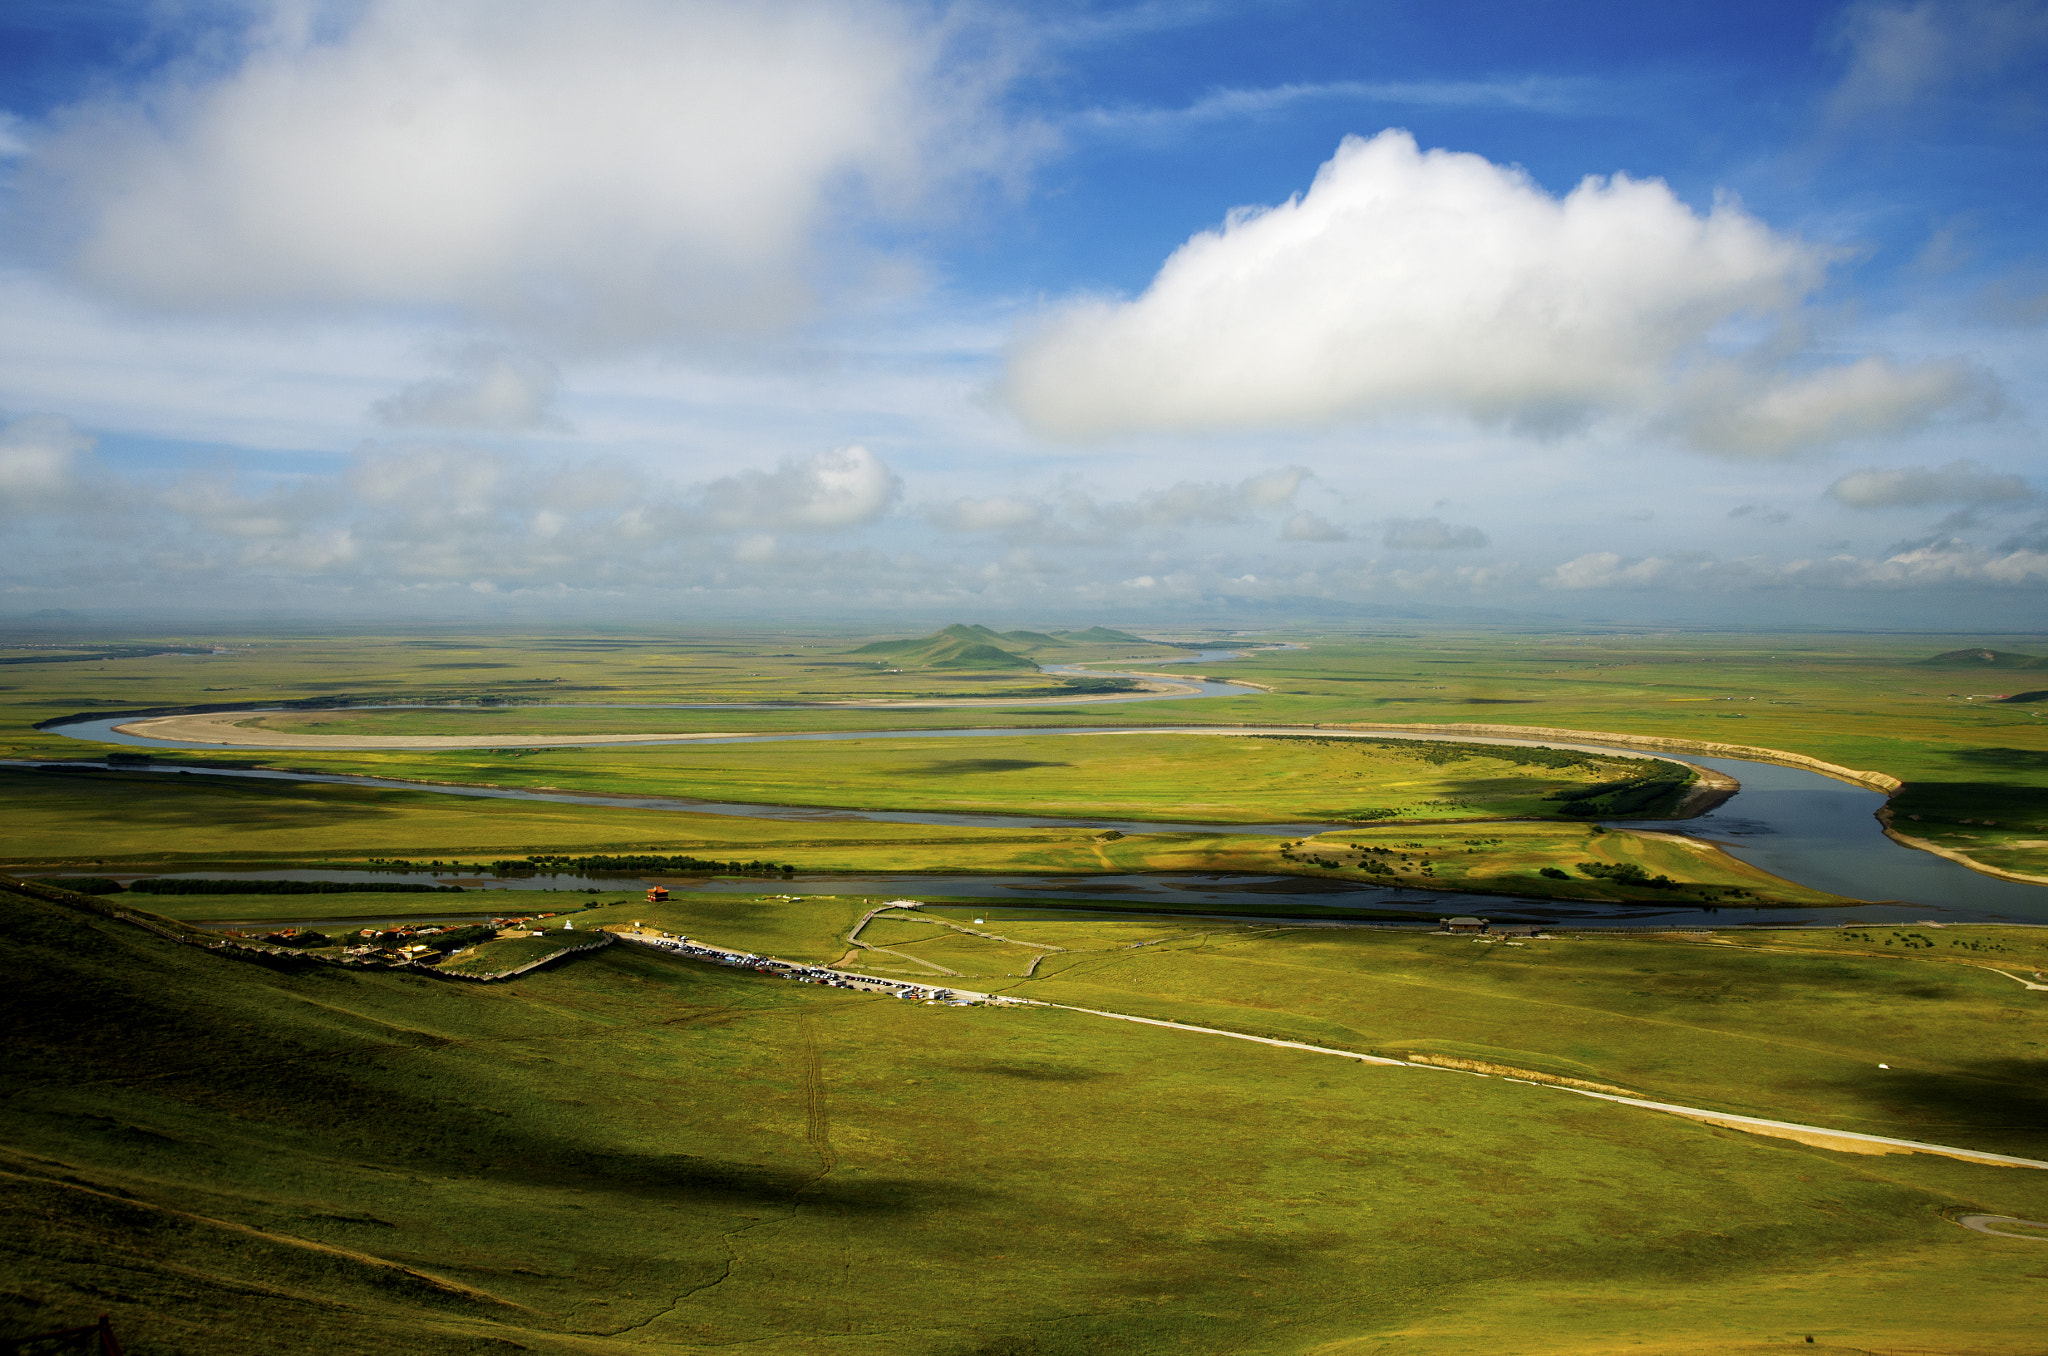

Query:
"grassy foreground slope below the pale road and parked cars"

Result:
[[0, 897, 2048, 1356]]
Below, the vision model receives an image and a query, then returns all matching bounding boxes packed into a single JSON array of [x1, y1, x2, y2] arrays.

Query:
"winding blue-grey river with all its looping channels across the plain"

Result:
[[28, 649, 2048, 928]]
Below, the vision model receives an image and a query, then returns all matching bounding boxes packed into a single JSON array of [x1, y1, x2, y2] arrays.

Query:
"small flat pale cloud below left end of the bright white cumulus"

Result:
[[926, 467, 1311, 545]]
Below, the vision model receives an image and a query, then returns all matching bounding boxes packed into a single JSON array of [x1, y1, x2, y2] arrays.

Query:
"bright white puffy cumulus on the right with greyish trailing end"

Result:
[[1001, 131, 1980, 453]]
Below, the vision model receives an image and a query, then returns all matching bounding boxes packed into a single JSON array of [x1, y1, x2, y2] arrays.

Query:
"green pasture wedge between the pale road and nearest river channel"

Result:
[[625, 897, 2048, 1159]]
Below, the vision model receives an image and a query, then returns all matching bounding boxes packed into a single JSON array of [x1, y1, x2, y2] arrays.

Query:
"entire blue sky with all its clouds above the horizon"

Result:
[[0, 0, 2048, 629]]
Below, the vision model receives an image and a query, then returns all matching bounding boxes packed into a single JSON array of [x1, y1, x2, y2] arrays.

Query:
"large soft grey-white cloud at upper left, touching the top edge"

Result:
[[23, 0, 1016, 342]]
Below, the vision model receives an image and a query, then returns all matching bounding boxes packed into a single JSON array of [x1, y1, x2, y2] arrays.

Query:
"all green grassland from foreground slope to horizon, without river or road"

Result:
[[0, 631, 2048, 1356]]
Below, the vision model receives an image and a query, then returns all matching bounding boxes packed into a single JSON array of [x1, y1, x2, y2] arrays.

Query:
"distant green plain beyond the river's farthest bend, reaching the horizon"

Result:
[[12, 631, 2048, 873]]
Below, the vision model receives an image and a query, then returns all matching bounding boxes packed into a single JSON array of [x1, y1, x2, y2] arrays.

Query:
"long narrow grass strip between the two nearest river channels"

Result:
[[0, 770, 1841, 920]]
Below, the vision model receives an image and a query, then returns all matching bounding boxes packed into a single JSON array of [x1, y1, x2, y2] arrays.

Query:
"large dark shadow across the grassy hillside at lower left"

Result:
[[0, 893, 987, 1215]]
